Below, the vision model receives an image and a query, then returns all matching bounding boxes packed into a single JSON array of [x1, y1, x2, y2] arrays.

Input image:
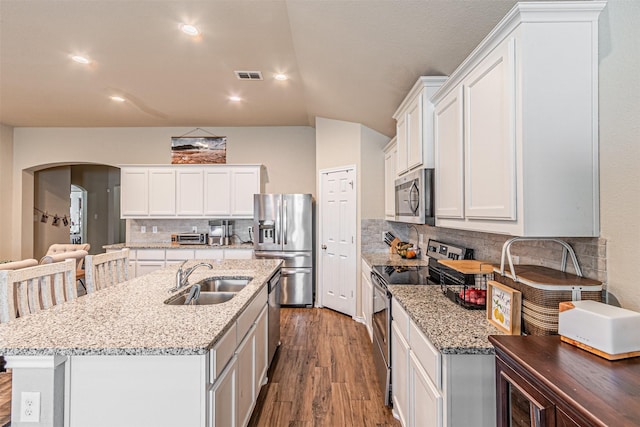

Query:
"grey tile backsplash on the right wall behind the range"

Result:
[[361, 219, 607, 283]]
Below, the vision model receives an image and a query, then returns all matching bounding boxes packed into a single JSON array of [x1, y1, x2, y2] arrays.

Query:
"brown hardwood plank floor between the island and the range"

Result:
[[249, 308, 400, 427]]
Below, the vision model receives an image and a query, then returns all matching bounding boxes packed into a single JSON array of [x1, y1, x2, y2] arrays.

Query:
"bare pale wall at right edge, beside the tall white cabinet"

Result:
[[599, 0, 640, 311]]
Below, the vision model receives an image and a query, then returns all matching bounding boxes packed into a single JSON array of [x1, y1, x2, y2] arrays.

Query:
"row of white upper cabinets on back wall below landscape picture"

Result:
[[120, 165, 261, 218]]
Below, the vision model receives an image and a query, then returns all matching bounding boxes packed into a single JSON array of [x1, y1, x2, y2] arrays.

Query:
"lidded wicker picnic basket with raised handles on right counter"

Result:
[[494, 237, 602, 335]]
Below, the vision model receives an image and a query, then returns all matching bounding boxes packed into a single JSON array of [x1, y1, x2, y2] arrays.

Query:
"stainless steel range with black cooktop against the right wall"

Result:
[[371, 240, 473, 406]]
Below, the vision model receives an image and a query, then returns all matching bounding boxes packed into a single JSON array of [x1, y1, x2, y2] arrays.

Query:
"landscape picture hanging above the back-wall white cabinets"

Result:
[[171, 136, 227, 165]]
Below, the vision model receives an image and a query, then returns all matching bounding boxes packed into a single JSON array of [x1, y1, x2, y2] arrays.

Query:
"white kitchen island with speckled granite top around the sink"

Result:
[[0, 260, 281, 427]]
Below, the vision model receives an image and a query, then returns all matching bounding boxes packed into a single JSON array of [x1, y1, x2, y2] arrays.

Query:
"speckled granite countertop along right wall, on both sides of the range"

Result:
[[362, 253, 504, 354]]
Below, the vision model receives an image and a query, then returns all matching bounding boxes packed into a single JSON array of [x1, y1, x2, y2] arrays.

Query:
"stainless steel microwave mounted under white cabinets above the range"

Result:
[[395, 169, 436, 225]]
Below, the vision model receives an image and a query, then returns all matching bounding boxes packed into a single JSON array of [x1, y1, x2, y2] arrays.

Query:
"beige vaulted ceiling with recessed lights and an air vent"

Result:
[[0, 0, 515, 136]]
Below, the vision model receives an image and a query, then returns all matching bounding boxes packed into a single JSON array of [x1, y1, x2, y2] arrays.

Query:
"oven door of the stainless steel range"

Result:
[[371, 272, 391, 406]]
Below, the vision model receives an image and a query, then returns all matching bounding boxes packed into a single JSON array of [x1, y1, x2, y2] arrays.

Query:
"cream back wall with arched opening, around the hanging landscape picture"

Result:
[[8, 126, 315, 258]]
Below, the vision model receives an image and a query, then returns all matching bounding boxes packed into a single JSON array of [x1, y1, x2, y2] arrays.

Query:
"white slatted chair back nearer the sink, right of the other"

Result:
[[85, 248, 129, 294]]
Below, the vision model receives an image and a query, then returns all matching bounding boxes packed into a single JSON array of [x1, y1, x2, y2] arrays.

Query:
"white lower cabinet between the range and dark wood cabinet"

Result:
[[391, 299, 496, 427]]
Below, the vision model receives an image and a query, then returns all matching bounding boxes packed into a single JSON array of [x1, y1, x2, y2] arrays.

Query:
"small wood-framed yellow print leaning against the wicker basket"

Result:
[[487, 280, 522, 335]]
